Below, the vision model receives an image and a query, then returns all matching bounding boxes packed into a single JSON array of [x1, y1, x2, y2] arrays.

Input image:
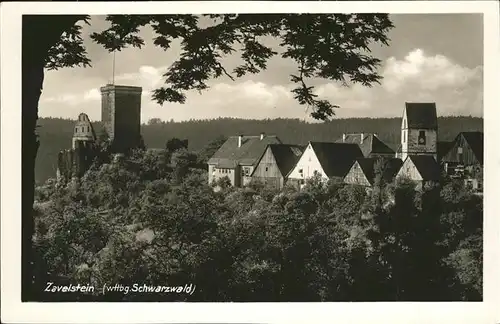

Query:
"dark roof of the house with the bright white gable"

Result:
[[310, 142, 363, 177]]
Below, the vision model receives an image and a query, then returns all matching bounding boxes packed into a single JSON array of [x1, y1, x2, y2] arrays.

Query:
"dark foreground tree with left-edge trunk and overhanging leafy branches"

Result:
[[22, 14, 393, 301]]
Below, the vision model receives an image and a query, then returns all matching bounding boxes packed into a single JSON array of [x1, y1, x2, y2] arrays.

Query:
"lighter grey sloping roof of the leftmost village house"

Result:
[[208, 135, 281, 168]]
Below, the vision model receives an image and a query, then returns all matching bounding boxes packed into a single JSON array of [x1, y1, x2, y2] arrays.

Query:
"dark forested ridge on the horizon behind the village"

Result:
[[36, 117, 483, 183]]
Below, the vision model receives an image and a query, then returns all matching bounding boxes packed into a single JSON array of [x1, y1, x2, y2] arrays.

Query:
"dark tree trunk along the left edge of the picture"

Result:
[[21, 15, 78, 302]]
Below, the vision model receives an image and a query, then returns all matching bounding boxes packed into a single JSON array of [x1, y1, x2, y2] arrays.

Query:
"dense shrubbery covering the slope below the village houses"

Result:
[[34, 144, 482, 301]]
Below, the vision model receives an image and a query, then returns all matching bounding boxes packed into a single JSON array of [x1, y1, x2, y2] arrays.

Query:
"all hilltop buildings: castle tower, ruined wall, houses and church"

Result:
[[57, 84, 483, 192]]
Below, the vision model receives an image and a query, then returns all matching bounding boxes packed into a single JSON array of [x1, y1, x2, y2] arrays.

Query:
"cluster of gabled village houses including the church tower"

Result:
[[208, 103, 483, 188]]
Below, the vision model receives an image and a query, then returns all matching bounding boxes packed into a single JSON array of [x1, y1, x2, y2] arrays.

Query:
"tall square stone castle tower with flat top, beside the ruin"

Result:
[[101, 84, 142, 152]]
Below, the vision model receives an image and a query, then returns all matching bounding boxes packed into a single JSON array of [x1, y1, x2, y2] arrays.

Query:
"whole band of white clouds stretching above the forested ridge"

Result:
[[37, 49, 483, 122]]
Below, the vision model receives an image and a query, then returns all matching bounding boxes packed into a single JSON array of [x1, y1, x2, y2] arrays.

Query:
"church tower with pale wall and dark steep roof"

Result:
[[401, 102, 438, 161]]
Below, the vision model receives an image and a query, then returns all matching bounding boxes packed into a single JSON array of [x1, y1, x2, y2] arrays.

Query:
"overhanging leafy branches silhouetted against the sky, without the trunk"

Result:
[[46, 14, 393, 120]]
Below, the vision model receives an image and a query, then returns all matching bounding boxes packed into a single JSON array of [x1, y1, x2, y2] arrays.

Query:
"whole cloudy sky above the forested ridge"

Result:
[[39, 14, 483, 123]]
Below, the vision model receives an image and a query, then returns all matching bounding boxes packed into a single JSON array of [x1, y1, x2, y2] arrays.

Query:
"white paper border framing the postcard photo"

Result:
[[0, 1, 500, 324]]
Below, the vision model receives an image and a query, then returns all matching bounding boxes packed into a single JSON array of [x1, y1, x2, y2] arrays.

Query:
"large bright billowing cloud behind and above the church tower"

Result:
[[310, 49, 483, 117]]
